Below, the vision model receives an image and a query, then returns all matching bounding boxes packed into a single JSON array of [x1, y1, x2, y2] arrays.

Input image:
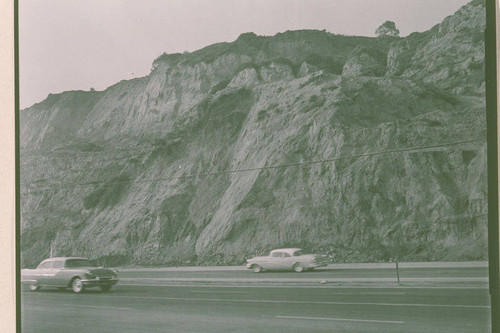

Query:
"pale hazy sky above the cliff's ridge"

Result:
[[19, 0, 469, 109]]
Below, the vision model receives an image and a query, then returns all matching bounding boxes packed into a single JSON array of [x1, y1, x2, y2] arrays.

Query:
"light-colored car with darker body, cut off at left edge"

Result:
[[21, 257, 118, 293]]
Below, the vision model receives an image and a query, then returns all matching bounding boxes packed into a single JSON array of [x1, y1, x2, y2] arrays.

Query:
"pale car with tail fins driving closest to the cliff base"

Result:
[[246, 248, 328, 273]]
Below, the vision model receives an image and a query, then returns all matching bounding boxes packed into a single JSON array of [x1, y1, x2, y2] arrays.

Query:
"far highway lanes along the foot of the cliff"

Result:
[[114, 263, 488, 287]]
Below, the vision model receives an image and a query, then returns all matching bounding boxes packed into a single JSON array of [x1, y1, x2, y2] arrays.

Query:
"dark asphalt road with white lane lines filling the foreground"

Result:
[[21, 268, 490, 333]]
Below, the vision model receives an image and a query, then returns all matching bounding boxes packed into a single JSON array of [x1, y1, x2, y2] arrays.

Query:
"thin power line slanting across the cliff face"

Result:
[[21, 139, 484, 194]]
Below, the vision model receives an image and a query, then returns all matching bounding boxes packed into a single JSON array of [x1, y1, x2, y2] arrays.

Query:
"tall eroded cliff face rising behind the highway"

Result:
[[21, 2, 487, 266]]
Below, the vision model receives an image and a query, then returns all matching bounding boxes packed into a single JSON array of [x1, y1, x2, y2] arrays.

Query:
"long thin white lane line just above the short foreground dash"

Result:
[[101, 296, 490, 308]]
